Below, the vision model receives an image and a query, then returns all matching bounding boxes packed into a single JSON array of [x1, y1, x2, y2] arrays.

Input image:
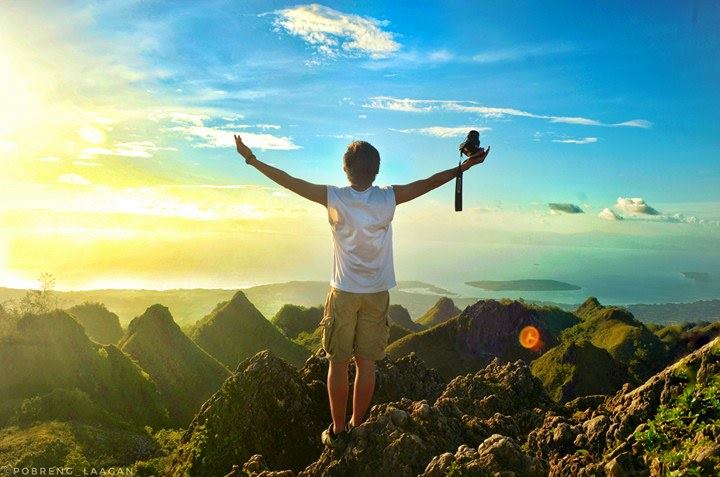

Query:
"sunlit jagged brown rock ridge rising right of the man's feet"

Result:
[[300, 360, 555, 476]]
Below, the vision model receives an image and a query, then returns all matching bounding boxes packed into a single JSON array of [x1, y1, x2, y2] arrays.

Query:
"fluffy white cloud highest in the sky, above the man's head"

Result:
[[273, 3, 400, 59]]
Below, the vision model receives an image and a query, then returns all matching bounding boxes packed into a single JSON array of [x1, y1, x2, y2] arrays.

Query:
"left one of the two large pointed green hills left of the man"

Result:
[[118, 304, 230, 427]]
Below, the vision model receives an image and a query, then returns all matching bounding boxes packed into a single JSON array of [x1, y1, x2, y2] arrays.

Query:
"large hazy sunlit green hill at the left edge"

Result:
[[0, 309, 168, 427]]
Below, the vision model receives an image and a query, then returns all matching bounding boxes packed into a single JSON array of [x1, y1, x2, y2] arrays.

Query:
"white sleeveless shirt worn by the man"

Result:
[[327, 185, 396, 293]]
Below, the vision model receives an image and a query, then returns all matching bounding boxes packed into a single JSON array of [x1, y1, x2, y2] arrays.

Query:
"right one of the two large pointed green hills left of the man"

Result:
[[191, 291, 310, 370]]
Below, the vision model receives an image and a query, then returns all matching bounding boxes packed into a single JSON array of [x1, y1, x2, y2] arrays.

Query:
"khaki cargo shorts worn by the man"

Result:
[[320, 287, 390, 361]]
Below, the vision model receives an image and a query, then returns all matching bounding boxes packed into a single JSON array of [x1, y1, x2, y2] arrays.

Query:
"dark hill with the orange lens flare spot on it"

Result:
[[386, 300, 557, 380]]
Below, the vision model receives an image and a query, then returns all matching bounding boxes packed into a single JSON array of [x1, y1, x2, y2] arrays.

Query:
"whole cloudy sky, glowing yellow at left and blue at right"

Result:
[[0, 0, 720, 294]]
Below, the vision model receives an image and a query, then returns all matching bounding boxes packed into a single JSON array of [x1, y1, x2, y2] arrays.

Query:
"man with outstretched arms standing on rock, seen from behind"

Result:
[[235, 135, 490, 449]]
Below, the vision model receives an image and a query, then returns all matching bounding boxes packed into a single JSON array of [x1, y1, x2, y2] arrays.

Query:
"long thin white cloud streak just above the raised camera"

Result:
[[363, 96, 652, 129]]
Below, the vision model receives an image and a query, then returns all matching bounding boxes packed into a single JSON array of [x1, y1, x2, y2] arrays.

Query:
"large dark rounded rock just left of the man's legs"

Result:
[[169, 350, 327, 476]]
